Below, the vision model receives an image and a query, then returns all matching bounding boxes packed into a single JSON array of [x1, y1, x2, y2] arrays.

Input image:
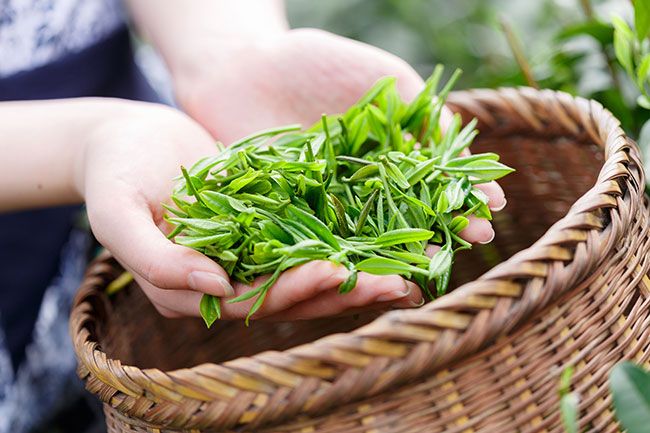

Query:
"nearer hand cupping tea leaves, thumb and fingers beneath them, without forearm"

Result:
[[77, 102, 422, 320]]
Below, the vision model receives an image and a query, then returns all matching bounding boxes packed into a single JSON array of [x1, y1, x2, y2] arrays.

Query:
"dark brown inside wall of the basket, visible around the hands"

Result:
[[98, 134, 604, 370]]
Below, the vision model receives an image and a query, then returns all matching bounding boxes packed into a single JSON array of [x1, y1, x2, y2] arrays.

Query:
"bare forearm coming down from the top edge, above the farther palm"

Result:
[[125, 0, 288, 76]]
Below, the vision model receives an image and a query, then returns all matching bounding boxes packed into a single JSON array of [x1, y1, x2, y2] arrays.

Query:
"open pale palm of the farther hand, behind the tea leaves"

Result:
[[177, 29, 423, 144]]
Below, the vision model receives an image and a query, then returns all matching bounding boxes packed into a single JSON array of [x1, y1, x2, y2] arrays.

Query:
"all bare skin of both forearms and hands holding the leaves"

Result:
[[0, 0, 505, 320]]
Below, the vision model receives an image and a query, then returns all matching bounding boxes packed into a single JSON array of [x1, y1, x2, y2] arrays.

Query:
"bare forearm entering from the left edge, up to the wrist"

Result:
[[0, 98, 130, 211]]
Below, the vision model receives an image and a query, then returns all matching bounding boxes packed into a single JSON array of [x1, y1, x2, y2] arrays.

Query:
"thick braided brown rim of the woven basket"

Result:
[[70, 87, 645, 428]]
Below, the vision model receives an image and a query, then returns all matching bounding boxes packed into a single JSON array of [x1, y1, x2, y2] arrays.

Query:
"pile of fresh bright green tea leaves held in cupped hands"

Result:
[[166, 67, 513, 326]]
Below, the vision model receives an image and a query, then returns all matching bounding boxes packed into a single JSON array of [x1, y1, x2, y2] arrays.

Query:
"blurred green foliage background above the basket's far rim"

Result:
[[286, 0, 650, 137]]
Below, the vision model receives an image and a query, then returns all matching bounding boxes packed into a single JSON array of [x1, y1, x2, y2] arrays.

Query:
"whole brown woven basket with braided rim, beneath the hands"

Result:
[[70, 88, 650, 433]]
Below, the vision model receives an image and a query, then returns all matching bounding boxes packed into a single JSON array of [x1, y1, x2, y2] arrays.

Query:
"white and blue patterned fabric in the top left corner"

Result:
[[0, 0, 124, 78]]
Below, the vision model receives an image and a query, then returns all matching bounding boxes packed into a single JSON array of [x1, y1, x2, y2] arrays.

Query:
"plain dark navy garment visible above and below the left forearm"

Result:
[[0, 25, 158, 367]]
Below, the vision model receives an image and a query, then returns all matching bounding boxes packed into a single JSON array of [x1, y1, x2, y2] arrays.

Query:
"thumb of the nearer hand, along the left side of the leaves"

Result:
[[88, 199, 234, 296]]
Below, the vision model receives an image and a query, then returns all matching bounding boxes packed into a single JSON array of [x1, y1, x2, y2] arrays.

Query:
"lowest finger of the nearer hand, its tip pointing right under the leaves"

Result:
[[270, 272, 423, 320]]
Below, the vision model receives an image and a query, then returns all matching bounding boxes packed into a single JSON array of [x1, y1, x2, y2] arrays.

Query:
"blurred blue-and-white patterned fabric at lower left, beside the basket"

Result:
[[0, 229, 92, 433]]
